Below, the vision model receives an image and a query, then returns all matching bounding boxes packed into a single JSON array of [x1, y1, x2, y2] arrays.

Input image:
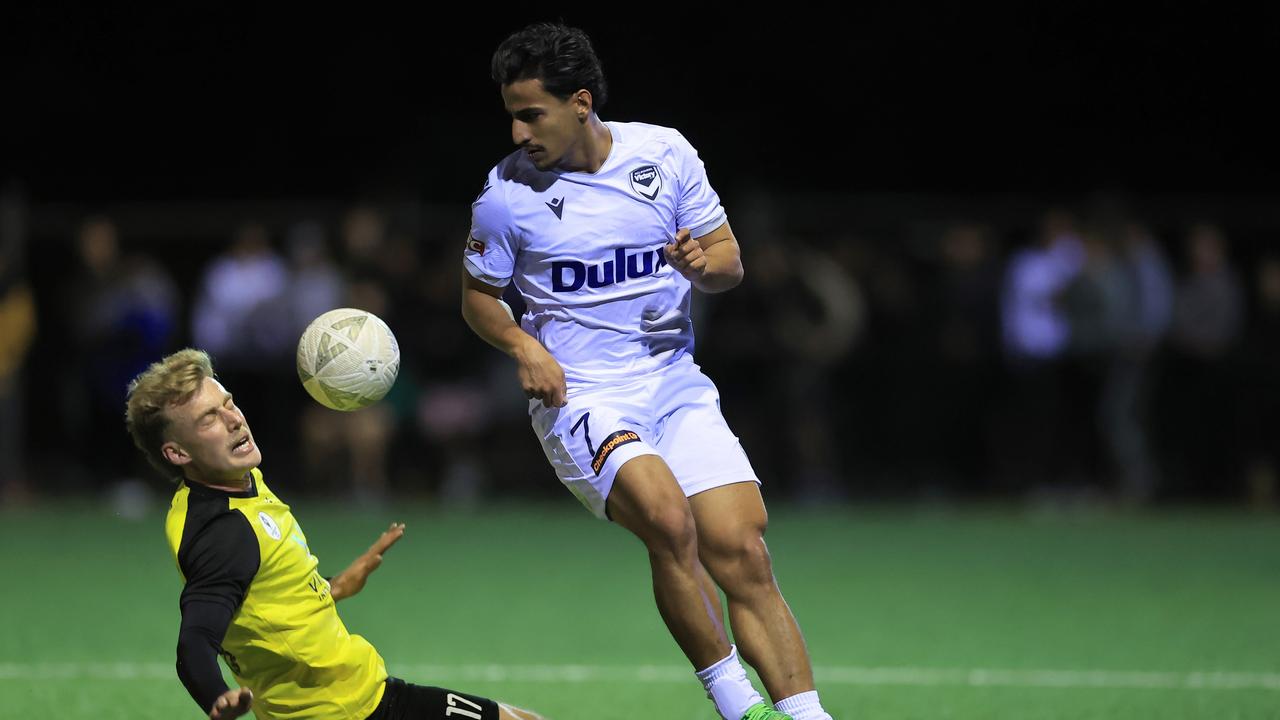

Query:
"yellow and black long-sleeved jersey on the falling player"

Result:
[[165, 469, 387, 720]]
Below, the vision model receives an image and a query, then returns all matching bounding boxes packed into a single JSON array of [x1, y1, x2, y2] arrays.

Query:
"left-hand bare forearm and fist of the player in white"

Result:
[[462, 262, 567, 407]]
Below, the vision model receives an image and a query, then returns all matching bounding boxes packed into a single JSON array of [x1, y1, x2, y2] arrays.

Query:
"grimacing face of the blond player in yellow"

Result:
[[161, 378, 262, 486]]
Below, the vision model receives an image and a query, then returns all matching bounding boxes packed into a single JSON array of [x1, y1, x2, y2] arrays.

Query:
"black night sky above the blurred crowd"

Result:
[[10, 4, 1280, 201]]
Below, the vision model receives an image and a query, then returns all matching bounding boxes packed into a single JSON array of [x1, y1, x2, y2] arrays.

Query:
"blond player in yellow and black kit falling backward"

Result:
[[125, 350, 538, 720]]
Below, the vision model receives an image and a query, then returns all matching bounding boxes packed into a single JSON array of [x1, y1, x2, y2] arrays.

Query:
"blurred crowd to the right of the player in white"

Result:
[[700, 197, 1280, 506]]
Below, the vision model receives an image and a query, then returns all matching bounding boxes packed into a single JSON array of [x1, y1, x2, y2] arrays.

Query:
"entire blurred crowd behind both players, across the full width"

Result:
[[0, 188, 1280, 507]]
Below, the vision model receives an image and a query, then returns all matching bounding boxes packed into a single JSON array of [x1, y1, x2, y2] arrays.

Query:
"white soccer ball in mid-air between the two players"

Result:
[[298, 307, 399, 411]]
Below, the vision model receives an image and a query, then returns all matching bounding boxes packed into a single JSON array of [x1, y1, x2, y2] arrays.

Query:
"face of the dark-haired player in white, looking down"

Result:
[[502, 79, 590, 170]]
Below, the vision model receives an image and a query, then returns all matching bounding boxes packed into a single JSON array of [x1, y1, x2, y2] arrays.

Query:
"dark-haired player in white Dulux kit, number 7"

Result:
[[462, 23, 831, 720]]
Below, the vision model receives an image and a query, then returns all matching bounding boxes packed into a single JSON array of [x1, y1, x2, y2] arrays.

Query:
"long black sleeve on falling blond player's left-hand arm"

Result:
[[178, 512, 260, 714]]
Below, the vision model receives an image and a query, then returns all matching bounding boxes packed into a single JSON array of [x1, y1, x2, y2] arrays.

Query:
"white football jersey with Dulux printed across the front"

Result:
[[463, 122, 726, 388]]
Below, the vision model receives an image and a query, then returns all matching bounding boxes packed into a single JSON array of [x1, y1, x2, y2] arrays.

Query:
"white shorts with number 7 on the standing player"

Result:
[[529, 363, 760, 519]]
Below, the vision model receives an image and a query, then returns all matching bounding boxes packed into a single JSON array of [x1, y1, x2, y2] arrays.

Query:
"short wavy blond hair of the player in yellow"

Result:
[[124, 347, 215, 480]]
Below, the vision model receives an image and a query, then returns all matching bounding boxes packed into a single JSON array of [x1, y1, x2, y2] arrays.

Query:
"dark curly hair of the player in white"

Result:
[[492, 23, 609, 109]]
